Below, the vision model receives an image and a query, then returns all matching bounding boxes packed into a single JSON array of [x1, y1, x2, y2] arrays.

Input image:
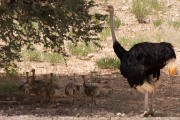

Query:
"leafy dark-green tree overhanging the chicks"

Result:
[[0, 0, 105, 74]]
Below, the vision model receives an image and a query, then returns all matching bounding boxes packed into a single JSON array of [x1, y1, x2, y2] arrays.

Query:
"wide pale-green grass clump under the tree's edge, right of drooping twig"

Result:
[[68, 42, 97, 56]]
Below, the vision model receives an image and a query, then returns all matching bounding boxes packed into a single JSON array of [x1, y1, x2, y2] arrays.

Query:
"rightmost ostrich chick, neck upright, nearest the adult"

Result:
[[82, 75, 100, 104]]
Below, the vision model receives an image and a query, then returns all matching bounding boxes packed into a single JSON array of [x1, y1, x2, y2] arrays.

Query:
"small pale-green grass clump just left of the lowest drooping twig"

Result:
[[44, 53, 63, 64]]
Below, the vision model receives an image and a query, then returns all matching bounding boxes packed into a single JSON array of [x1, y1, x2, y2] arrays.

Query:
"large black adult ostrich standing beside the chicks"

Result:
[[104, 5, 177, 117]]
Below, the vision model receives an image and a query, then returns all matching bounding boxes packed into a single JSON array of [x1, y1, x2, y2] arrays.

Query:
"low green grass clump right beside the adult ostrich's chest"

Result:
[[96, 57, 120, 69]]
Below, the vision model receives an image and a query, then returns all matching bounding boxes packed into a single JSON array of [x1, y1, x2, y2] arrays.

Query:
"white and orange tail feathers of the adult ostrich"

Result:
[[166, 59, 178, 76]]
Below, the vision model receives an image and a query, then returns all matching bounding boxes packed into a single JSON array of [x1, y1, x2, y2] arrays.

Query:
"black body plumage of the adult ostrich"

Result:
[[113, 42, 176, 88]]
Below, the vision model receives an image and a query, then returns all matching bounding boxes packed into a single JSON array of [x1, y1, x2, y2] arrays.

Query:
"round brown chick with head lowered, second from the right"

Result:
[[65, 83, 80, 104]]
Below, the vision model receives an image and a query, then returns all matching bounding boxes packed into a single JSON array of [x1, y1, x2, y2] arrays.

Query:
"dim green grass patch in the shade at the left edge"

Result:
[[0, 79, 18, 93]]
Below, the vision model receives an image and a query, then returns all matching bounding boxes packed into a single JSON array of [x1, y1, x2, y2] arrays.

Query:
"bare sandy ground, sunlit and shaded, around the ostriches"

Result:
[[0, 0, 180, 120]]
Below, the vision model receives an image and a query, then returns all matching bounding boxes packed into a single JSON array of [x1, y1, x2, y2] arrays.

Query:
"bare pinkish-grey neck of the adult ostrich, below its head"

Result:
[[110, 11, 116, 43]]
